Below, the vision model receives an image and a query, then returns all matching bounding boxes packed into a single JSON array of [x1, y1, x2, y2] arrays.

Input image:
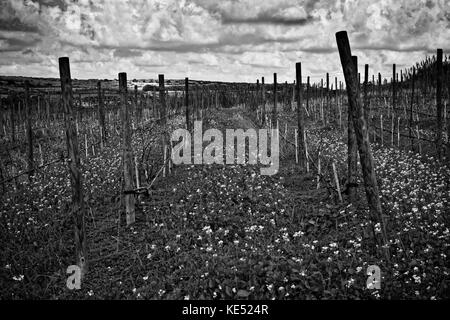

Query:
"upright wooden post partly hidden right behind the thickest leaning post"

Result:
[[347, 56, 359, 202]]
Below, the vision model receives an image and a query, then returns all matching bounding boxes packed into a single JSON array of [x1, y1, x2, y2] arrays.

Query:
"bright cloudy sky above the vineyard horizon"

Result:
[[0, 0, 450, 82]]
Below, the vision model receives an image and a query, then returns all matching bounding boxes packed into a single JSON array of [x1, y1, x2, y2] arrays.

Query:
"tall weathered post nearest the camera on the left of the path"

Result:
[[59, 57, 88, 277]]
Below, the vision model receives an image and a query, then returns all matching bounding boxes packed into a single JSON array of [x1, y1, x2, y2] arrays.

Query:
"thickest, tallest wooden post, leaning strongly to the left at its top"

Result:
[[336, 31, 390, 262]]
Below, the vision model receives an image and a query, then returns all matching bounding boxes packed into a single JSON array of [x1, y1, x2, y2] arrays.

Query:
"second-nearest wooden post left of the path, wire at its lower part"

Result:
[[119, 72, 135, 226]]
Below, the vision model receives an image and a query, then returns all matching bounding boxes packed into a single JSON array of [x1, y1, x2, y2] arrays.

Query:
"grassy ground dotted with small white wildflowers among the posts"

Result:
[[0, 105, 450, 299]]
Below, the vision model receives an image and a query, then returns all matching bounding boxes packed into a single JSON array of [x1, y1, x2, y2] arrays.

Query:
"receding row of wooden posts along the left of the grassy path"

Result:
[[56, 57, 225, 275]]
